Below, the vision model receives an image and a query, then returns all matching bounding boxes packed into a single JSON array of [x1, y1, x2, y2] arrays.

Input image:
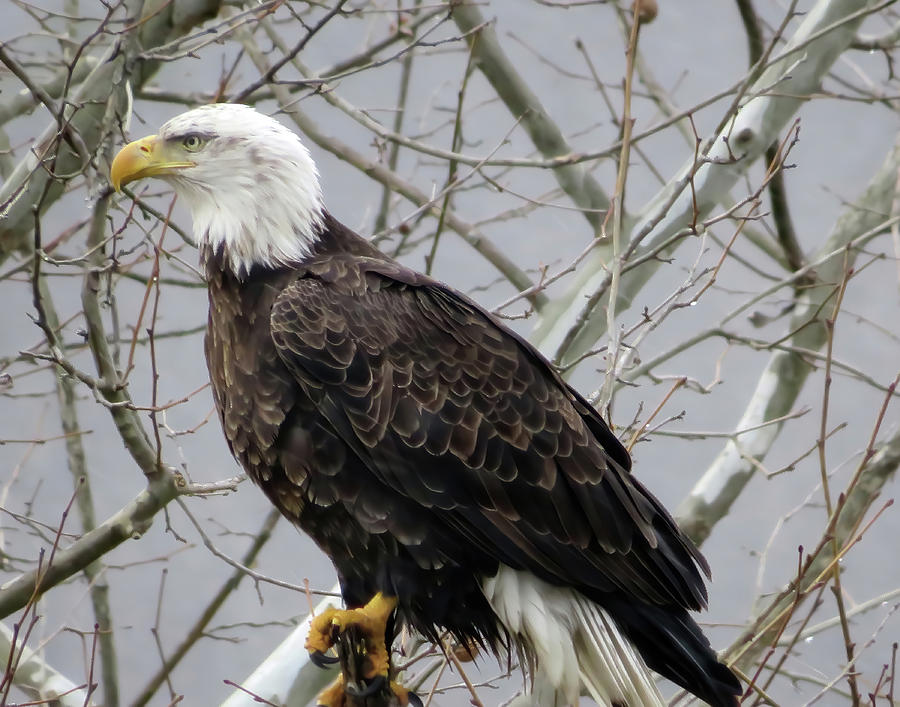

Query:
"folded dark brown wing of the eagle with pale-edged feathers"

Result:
[[271, 256, 706, 609]]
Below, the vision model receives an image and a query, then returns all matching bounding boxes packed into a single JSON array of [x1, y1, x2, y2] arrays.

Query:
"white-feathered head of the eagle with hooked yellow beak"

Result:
[[110, 103, 324, 277]]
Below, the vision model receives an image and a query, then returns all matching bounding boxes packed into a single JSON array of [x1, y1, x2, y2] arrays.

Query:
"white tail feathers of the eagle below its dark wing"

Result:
[[484, 565, 666, 707]]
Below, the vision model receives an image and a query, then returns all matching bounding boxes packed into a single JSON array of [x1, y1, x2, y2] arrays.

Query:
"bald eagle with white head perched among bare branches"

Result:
[[111, 104, 740, 707]]
